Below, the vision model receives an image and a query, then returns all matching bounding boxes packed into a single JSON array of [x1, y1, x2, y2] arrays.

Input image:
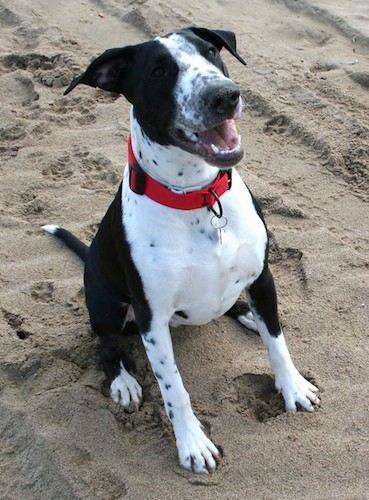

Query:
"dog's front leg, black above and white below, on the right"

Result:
[[244, 268, 320, 412]]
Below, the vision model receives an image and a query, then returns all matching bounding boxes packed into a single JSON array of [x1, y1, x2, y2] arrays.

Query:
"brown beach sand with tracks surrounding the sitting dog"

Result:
[[0, 0, 369, 500]]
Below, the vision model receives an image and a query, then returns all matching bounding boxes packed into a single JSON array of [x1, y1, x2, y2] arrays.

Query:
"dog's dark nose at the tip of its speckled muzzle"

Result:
[[204, 82, 240, 116]]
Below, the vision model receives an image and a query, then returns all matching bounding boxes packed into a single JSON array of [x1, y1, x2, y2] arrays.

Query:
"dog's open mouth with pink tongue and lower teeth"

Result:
[[171, 119, 243, 168]]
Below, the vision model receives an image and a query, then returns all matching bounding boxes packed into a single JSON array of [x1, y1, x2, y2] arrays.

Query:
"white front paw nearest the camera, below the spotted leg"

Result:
[[176, 417, 221, 474]]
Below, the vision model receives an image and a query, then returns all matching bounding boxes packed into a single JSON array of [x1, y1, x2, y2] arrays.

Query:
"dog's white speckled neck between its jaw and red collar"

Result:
[[131, 110, 219, 191]]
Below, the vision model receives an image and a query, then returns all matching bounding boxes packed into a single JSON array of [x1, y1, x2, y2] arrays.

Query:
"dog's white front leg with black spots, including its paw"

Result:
[[142, 319, 220, 473]]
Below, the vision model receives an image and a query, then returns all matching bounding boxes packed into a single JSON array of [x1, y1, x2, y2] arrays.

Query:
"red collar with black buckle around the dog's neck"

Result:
[[128, 135, 232, 210]]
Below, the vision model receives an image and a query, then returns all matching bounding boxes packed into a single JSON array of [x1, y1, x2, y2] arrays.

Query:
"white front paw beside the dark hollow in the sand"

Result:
[[275, 368, 320, 413]]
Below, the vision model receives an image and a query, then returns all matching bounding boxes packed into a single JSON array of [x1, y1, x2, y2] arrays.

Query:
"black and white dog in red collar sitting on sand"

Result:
[[44, 27, 319, 472]]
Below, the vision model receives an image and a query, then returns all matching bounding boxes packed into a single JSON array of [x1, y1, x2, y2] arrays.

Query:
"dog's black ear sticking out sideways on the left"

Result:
[[64, 46, 134, 95]]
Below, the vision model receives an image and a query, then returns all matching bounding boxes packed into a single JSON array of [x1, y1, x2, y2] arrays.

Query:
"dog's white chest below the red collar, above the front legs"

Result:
[[123, 168, 266, 326]]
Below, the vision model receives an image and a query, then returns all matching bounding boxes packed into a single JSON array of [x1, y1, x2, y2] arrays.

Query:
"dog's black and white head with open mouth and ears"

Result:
[[65, 27, 246, 167]]
